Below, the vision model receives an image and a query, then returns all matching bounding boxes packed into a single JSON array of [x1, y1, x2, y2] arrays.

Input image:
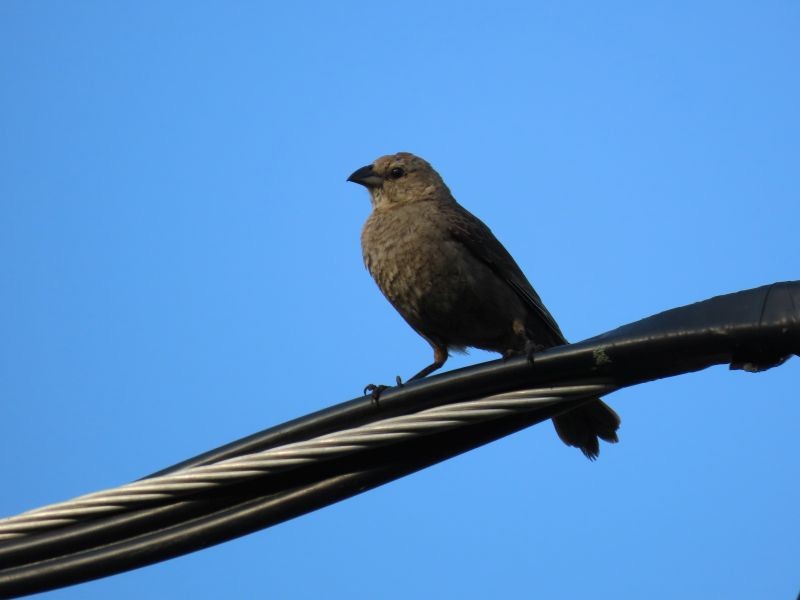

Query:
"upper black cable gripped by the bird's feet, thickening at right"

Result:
[[150, 281, 800, 477]]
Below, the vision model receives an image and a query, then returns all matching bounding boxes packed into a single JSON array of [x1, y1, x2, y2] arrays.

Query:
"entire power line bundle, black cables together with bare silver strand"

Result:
[[0, 282, 800, 597]]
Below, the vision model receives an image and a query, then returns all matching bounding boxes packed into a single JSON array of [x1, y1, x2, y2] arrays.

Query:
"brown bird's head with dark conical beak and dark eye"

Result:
[[347, 152, 450, 208]]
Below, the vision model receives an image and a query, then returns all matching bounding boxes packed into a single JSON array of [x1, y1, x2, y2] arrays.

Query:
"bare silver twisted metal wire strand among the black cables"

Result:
[[0, 384, 616, 541]]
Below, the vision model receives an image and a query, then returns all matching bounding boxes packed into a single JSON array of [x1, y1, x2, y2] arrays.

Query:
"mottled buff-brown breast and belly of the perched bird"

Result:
[[361, 204, 527, 352]]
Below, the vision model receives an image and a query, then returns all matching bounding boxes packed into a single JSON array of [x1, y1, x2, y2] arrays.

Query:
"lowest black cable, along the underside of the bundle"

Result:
[[0, 403, 574, 596]]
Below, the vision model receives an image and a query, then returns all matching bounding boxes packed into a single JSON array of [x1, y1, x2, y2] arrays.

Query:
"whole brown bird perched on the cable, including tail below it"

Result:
[[348, 152, 620, 459]]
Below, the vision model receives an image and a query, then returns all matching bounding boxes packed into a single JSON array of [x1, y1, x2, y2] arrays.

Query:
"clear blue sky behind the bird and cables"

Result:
[[0, 0, 800, 600]]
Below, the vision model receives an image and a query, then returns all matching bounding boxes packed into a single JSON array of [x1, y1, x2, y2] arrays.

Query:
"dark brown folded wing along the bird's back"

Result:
[[448, 203, 567, 344]]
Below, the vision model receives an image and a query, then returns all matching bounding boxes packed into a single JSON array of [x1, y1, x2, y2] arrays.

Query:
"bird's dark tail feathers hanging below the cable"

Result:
[[553, 398, 620, 460]]
